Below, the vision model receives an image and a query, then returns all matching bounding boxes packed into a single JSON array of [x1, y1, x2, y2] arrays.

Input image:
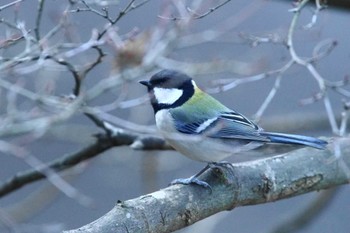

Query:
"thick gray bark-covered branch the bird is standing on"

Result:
[[66, 138, 350, 233]]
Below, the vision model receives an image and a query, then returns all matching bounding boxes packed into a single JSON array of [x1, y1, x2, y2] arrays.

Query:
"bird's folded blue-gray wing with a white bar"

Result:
[[174, 111, 270, 142]]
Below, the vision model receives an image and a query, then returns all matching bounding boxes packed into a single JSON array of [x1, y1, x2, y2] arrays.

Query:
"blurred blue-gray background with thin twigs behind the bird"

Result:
[[0, 0, 350, 233]]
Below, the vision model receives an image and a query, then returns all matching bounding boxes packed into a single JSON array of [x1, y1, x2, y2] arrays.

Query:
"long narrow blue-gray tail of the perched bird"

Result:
[[260, 132, 328, 149]]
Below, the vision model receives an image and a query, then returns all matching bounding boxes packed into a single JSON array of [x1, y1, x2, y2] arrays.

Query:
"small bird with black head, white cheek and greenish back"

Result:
[[139, 69, 327, 188]]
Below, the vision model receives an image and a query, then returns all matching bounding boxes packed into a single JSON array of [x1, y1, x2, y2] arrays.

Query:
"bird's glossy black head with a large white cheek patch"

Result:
[[140, 70, 196, 113]]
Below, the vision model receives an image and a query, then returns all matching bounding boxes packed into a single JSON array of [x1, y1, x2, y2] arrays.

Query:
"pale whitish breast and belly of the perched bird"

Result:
[[155, 110, 261, 162]]
